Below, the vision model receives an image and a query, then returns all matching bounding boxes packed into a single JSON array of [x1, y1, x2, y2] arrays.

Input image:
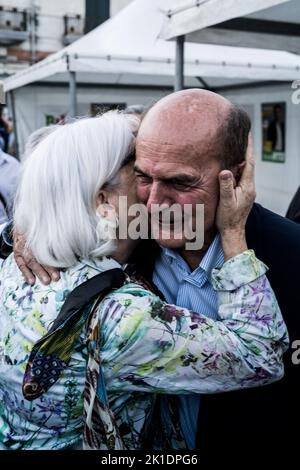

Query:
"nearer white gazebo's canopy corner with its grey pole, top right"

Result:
[[160, 0, 300, 89]]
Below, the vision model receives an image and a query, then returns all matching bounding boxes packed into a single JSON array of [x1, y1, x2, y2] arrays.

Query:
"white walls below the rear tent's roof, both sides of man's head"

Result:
[[15, 80, 300, 215]]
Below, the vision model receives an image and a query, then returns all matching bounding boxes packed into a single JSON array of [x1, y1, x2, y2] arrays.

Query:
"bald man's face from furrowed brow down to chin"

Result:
[[135, 137, 221, 250]]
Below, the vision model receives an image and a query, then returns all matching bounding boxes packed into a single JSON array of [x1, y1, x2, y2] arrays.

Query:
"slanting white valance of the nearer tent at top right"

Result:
[[160, 0, 290, 39]]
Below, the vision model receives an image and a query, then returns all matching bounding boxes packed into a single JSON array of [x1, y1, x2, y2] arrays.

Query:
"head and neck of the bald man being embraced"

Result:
[[135, 90, 250, 271]]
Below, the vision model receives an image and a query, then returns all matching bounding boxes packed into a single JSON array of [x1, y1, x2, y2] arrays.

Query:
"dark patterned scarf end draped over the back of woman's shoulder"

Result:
[[22, 269, 126, 400]]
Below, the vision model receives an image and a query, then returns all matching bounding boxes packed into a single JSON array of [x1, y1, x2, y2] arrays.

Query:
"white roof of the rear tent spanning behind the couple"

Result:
[[4, 0, 300, 91]]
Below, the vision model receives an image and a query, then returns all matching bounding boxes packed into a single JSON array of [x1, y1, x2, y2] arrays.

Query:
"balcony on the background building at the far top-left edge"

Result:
[[0, 6, 29, 46]]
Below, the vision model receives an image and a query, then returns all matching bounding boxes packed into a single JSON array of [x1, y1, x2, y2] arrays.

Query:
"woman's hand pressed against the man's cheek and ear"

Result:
[[216, 136, 256, 261]]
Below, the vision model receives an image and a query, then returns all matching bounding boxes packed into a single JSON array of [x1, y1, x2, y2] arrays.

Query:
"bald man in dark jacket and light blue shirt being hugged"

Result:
[[3, 89, 300, 464]]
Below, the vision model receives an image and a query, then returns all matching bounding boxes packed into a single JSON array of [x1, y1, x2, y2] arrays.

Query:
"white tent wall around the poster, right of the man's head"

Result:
[[223, 84, 300, 215]]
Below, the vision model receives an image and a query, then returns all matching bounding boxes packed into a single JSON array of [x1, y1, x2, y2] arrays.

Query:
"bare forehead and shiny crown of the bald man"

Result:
[[137, 90, 232, 167]]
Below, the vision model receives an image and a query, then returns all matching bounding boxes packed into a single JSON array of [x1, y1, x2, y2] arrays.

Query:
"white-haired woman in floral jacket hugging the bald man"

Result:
[[0, 112, 287, 449]]
